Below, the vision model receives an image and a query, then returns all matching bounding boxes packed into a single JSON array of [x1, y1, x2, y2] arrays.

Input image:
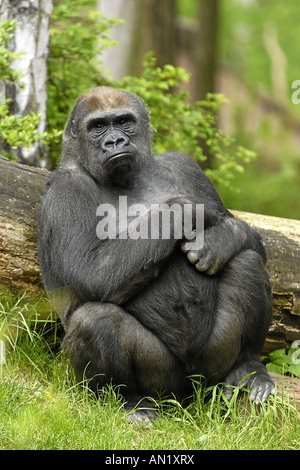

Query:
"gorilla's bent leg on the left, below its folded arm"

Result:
[[62, 302, 185, 395]]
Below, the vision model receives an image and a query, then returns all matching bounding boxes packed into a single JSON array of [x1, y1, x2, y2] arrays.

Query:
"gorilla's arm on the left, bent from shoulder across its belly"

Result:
[[39, 170, 191, 304]]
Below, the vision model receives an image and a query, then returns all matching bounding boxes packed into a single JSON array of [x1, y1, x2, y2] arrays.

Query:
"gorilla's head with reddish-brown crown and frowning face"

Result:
[[61, 87, 152, 184]]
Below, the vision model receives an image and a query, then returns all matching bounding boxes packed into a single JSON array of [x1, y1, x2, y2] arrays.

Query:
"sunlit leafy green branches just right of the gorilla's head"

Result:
[[117, 53, 255, 186]]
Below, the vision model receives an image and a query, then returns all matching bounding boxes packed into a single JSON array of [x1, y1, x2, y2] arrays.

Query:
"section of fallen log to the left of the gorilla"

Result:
[[0, 156, 48, 294]]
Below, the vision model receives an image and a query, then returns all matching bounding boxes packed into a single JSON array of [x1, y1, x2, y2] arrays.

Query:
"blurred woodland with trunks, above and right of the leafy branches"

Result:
[[98, 0, 300, 218]]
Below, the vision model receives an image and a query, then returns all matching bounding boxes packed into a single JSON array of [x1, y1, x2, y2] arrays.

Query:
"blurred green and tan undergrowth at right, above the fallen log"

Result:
[[177, 0, 300, 218]]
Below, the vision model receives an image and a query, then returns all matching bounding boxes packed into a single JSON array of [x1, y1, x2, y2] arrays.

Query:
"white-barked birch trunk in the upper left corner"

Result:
[[0, 0, 53, 167]]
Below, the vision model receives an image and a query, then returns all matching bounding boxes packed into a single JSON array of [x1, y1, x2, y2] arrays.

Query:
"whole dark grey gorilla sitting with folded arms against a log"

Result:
[[38, 87, 274, 420]]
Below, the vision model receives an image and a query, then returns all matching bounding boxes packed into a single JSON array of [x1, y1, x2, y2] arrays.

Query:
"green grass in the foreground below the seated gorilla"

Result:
[[0, 297, 300, 450]]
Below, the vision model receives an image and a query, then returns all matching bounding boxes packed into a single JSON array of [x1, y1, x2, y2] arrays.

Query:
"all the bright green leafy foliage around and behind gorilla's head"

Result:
[[0, 0, 255, 186]]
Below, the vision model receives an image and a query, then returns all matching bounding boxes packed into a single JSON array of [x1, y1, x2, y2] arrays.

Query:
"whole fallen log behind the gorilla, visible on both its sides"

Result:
[[0, 157, 300, 352]]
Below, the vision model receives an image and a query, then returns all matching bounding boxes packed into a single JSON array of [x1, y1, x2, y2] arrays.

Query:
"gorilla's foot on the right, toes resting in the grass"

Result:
[[223, 360, 275, 404]]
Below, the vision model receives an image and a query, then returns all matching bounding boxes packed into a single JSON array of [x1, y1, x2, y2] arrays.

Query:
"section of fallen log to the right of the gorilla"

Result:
[[232, 211, 300, 351]]
